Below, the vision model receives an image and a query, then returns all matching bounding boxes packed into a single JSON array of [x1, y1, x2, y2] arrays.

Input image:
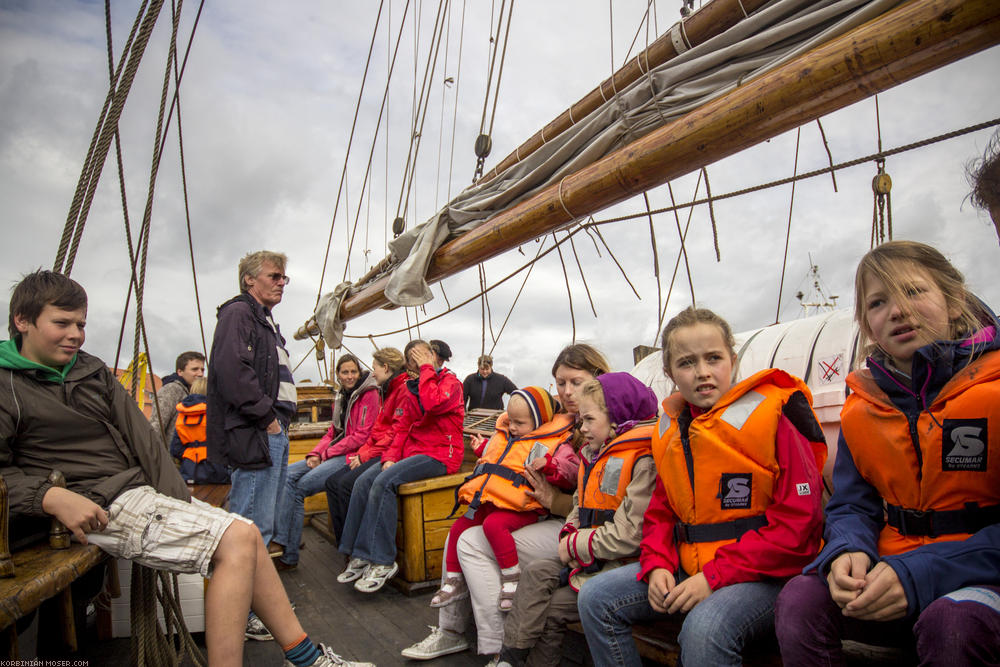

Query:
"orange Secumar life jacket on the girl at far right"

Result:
[[840, 352, 1000, 556]]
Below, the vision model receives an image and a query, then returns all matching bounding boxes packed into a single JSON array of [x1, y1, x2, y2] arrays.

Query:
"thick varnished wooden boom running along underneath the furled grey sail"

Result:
[[341, 0, 1000, 321]]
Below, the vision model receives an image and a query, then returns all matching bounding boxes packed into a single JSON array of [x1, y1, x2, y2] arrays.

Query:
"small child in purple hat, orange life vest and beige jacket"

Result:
[[498, 373, 656, 667]]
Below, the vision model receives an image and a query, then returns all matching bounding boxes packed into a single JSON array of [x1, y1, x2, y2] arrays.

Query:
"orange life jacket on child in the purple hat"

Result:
[[576, 421, 655, 528]]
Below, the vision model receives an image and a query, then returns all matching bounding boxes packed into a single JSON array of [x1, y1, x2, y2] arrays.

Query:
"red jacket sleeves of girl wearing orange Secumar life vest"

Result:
[[639, 408, 823, 590]]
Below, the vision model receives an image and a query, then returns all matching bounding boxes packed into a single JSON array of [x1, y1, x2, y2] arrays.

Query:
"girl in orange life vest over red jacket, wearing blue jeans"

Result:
[[579, 308, 826, 667]]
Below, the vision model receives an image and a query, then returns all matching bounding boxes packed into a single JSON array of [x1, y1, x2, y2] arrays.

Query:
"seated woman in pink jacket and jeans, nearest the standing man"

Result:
[[269, 354, 380, 570]]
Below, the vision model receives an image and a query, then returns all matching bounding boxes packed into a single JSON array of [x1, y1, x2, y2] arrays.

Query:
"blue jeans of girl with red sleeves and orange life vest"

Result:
[[578, 563, 784, 667]]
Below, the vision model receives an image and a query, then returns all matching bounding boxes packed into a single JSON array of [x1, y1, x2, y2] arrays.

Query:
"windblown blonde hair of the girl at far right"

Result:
[[854, 241, 988, 356]]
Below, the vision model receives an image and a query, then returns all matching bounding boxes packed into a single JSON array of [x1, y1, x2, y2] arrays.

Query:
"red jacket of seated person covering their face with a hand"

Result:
[[382, 364, 465, 474]]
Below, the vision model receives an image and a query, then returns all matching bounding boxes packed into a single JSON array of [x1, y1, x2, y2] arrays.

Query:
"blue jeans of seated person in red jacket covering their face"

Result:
[[339, 454, 445, 565]]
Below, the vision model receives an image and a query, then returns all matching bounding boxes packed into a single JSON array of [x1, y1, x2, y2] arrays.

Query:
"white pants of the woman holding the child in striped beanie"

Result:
[[438, 519, 563, 655]]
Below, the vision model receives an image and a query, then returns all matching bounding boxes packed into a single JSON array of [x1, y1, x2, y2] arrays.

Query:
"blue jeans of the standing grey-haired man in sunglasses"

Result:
[[229, 426, 288, 544]]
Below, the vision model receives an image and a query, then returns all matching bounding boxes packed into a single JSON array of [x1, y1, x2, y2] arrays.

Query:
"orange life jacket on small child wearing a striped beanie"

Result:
[[457, 412, 573, 512]]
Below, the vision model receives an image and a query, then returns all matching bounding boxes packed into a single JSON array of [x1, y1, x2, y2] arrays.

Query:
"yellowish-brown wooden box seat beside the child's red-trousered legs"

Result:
[[393, 472, 468, 593]]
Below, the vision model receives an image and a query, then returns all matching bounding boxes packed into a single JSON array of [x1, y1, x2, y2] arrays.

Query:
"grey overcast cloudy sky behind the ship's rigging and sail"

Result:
[[0, 0, 1000, 394]]
